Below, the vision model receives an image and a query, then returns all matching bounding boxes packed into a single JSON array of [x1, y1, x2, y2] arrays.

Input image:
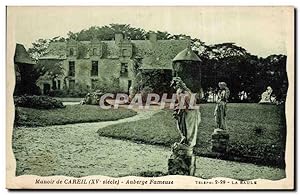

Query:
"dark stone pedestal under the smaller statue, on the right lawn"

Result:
[[211, 129, 229, 153]]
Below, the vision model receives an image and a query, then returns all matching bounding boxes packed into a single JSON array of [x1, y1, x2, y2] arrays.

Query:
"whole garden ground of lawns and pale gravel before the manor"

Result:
[[13, 100, 286, 180]]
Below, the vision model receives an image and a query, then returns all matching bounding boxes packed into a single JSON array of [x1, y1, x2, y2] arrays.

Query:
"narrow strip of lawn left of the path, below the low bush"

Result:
[[15, 105, 136, 127]]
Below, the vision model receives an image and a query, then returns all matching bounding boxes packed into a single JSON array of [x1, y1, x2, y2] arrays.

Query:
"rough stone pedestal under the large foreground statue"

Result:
[[168, 143, 196, 176]]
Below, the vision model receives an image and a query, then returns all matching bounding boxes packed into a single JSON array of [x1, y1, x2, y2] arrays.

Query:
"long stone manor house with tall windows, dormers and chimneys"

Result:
[[37, 33, 190, 94]]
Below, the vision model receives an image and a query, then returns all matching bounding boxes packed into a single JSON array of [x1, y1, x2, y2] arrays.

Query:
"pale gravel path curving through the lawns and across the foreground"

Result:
[[13, 110, 285, 179]]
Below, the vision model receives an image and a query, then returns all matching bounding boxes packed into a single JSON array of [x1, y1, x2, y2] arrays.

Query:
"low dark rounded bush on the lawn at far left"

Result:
[[14, 95, 65, 109]]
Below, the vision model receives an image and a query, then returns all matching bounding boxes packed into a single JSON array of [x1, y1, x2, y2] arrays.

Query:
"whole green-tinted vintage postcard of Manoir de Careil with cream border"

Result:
[[6, 6, 295, 190]]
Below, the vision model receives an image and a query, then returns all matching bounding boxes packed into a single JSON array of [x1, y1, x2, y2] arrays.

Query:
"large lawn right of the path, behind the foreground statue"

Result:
[[98, 103, 286, 168]]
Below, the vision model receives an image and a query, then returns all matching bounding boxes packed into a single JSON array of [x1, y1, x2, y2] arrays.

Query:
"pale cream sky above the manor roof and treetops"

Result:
[[7, 6, 293, 57]]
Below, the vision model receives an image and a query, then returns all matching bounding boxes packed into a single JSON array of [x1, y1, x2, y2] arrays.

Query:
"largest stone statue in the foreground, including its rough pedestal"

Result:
[[168, 77, 201, 175]]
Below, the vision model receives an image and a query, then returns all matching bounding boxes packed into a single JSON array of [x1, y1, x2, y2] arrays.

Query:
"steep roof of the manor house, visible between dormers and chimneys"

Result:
[[40, 40, 188, 69]]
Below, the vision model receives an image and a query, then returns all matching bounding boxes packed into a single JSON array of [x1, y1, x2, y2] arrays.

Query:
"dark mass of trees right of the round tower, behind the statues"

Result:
[[192, 41, 288, 102]]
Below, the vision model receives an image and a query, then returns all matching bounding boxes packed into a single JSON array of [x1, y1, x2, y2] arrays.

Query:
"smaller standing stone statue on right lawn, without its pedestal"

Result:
[[214, 82, 230, 130]]
